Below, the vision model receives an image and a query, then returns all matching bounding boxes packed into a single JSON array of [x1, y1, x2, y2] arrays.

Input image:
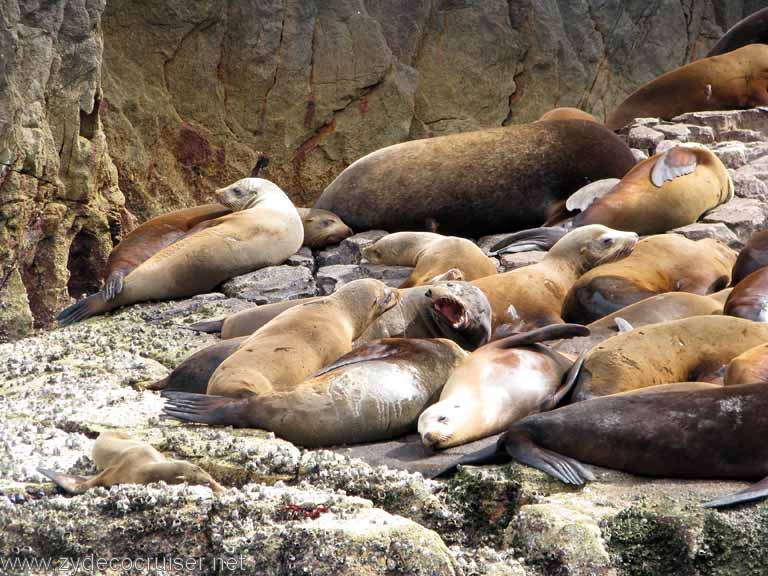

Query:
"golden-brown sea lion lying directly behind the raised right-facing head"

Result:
[[562, 234, 736, 324]]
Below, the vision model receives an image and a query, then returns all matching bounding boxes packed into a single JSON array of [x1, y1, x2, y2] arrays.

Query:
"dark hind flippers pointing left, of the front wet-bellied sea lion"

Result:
[[160, 390, 250, 428]]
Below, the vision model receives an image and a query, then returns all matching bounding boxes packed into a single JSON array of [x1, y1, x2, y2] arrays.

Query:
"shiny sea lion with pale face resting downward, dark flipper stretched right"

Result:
[[419, 324, 589, 449]]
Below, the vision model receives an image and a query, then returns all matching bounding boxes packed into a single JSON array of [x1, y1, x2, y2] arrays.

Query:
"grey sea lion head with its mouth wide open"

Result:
[[425, 282, 492, 350]]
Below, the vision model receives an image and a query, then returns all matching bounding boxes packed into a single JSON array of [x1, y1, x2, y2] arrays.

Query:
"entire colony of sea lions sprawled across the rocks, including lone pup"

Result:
[[44, 10, 768, 506]]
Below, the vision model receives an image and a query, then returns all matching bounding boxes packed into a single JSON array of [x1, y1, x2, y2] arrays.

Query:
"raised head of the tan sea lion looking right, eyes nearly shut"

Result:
[[549, 224, 639, 272]]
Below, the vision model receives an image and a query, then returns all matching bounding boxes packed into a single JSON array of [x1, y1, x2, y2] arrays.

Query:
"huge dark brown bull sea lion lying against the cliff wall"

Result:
[[315, 120, 635, 237]]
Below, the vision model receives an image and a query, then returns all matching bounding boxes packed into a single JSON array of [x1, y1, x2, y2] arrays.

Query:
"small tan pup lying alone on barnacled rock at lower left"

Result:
[[37, 432, 222, 494]]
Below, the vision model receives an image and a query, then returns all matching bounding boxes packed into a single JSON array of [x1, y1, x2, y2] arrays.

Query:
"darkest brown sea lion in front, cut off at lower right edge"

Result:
[[436, 383, 768, 507]]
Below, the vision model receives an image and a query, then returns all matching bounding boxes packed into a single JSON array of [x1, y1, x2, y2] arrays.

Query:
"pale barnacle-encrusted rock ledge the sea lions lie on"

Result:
[[0, 110, 768, 576]]
